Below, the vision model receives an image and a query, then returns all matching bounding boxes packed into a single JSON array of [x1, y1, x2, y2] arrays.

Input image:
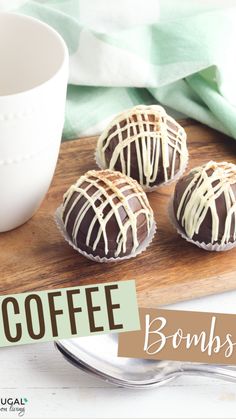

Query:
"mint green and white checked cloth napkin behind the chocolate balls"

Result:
[[18, 0, 236, 139]]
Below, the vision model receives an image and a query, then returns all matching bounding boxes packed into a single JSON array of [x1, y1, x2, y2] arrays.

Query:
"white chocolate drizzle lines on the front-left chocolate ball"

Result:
[[62, 170, 154, 257]]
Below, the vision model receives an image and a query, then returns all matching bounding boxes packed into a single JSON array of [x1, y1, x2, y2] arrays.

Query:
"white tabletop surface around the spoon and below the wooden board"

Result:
[[0, 291, 236, 419]]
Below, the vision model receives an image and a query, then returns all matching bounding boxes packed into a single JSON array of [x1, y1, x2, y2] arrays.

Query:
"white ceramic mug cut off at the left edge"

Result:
[[0, 12, 68, 232]]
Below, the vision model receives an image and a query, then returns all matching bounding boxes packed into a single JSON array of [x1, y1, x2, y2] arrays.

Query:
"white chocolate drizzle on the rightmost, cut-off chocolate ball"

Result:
[[176, 161, 236, 244]]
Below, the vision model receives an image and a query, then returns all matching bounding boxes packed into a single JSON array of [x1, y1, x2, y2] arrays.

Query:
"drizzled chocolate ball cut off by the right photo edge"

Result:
[[173, 161, 236, 247]]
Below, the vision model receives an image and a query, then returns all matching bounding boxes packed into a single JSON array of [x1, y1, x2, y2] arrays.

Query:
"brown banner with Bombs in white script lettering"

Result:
[[118, 308, 236, 364]]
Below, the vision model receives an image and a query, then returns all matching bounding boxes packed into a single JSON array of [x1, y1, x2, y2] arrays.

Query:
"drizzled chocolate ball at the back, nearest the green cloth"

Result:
[[96, 105, 188, 190]]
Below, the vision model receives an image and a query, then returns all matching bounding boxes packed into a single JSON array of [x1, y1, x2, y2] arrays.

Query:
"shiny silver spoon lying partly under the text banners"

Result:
[[56, 334, 236, 388]]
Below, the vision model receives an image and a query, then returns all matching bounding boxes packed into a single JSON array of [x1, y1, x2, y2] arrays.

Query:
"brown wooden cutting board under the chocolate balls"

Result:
[[0, 120, 236, 307]]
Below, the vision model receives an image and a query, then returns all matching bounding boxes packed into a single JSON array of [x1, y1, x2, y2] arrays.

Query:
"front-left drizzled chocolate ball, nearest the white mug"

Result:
[[62, 170, 154, 259]]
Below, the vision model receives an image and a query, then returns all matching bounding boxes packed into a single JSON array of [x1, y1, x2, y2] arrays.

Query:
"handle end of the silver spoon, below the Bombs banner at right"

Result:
[[180, 362, 236, 382]]
